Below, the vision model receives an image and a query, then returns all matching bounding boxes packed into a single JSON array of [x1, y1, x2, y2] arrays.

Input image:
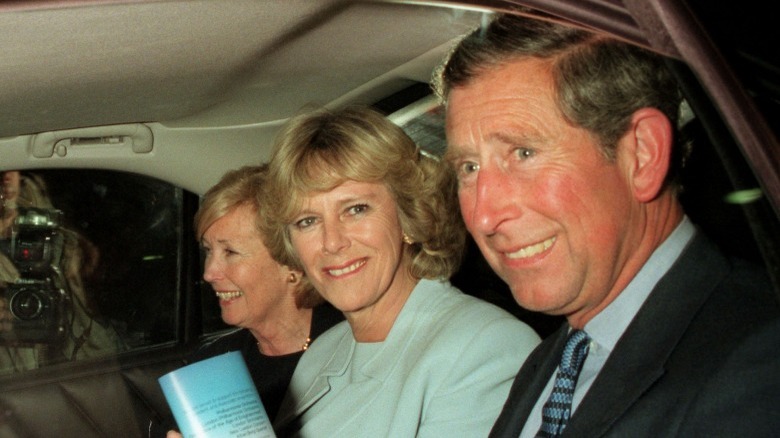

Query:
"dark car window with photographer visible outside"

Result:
[[0, 170, 184, 376]]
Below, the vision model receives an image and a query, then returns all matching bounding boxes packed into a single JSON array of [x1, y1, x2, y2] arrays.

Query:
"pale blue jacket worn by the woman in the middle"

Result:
[[274, 280, 539, 438]]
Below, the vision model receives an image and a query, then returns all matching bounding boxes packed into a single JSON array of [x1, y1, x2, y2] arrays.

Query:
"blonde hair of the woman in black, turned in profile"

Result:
[[194, 164, 322, 307]]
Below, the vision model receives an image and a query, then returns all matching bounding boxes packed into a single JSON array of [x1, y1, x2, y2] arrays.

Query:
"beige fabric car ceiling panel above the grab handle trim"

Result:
[[0, 0, 484, 136]]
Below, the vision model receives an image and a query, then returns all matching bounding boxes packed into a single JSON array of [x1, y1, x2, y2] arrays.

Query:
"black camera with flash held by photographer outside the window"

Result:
[[0, 208, 69, 345]]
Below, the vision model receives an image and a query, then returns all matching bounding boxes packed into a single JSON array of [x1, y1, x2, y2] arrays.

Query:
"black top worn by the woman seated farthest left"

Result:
[[149, 303, 344, 438]]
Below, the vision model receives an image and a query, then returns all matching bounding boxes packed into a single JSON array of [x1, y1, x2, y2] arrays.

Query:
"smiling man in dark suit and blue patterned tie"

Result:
[[436, 10, 780, 437]]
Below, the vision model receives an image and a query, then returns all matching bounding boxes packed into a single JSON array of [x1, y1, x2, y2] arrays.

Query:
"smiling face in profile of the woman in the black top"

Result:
[[202, 206, 294, 328]]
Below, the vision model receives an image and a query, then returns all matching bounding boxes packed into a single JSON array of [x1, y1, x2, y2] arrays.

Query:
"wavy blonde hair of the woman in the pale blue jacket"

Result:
[[260, 107, 466, 284]]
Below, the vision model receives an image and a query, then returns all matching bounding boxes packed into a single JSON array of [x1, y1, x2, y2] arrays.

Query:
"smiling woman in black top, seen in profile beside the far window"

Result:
[[150, 166, 343, 436]]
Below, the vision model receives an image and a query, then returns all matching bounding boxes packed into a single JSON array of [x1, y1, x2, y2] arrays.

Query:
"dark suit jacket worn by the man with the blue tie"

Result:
[[490, 232, 780, 437]]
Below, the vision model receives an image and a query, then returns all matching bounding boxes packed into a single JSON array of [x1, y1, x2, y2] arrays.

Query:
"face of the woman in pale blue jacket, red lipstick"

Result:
[[289, 181, 414, 314]]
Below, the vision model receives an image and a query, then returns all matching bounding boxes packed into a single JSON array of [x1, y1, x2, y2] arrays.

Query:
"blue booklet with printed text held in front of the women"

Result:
[[158, 351, 275, 438]]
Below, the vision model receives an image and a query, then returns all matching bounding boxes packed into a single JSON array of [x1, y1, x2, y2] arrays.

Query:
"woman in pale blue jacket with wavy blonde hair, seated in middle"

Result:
[[262, 108, 539, 437]]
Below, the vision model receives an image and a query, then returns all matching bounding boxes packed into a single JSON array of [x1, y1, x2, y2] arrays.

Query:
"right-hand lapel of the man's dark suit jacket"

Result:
[[565, 233, 728, 436]]
